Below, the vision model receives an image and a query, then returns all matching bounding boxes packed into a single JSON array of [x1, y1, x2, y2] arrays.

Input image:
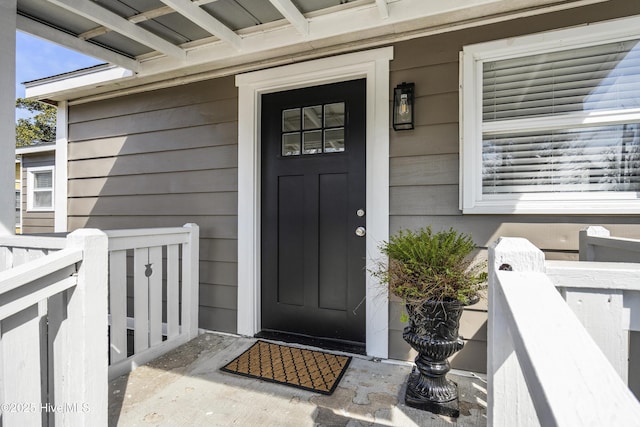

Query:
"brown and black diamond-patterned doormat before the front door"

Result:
[[221, 341, 351, 394]]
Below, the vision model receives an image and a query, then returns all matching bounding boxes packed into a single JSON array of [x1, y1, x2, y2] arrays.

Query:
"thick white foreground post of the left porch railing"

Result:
[[54, 229, 109, 426]]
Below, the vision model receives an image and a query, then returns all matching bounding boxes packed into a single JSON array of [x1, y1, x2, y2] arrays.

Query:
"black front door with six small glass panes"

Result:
[[261, 80, 366, 343]]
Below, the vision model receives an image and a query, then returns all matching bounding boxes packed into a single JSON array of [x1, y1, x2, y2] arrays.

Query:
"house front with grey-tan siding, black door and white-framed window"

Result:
[[8, 0, 640, 372]]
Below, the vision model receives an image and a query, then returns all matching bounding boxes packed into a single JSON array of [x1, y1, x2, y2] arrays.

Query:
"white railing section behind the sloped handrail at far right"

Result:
[[545, 227, 640, 394]]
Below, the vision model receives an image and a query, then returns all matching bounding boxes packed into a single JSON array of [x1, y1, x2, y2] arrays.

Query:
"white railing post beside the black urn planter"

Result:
[[487, 237, 544, 427]]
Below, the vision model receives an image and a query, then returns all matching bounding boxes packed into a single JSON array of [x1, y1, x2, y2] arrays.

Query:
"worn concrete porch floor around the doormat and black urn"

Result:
[[109, 333, 487, 427]]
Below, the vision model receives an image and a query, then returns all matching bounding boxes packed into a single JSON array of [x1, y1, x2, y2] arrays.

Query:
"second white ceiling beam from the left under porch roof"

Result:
[[47, 0, 187, 59]]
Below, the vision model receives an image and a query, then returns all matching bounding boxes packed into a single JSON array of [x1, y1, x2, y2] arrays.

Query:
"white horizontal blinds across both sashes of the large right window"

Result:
[[482, 40, 640, 194]]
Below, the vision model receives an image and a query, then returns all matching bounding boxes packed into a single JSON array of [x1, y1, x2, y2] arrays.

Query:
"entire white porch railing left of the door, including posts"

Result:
[[0, 224, 199, 427]]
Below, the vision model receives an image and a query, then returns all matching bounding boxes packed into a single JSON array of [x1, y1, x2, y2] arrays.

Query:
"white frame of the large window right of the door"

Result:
[[460, 17, 640, 214]]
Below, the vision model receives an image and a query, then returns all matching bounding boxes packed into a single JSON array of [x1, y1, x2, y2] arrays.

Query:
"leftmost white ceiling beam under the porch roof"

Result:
[[16, 15, 140, 71]]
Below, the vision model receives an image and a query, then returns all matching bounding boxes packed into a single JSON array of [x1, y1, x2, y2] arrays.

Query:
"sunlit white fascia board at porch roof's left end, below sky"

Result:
[[25, 66, 134, 99]]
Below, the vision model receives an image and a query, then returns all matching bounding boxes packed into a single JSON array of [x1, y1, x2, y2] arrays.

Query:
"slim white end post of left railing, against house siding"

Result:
[[182, 223, 200, 339]]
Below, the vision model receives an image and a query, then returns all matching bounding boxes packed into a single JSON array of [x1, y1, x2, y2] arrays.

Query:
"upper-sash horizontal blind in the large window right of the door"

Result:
[[482, 40, 640, 121]]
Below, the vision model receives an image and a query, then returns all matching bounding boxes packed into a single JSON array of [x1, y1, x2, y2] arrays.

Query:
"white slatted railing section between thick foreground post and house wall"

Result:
[[105, 224, 199, 379]]
